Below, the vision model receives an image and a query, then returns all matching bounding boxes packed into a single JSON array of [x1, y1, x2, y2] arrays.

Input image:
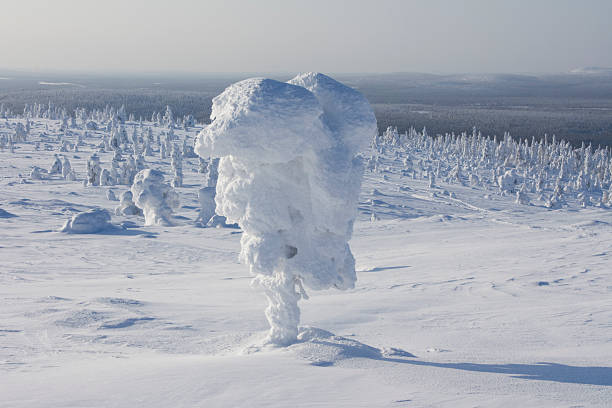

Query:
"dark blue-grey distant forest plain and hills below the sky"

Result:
[[0, 72, 612, 146]]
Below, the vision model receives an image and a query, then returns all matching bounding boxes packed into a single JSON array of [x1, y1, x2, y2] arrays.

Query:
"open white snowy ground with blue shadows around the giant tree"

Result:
[[0, 119, 612, 407]]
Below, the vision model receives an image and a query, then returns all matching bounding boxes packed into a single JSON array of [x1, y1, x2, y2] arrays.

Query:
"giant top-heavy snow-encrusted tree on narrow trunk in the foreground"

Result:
[[196, 73, 376, 345]]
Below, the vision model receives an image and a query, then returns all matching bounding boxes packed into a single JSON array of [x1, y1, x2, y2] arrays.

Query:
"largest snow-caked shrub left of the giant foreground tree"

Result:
[[131, 169, 179, 226]]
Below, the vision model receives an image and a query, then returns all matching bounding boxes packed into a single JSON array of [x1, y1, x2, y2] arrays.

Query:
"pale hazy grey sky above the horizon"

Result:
[[0, 0, 612, 73]]
